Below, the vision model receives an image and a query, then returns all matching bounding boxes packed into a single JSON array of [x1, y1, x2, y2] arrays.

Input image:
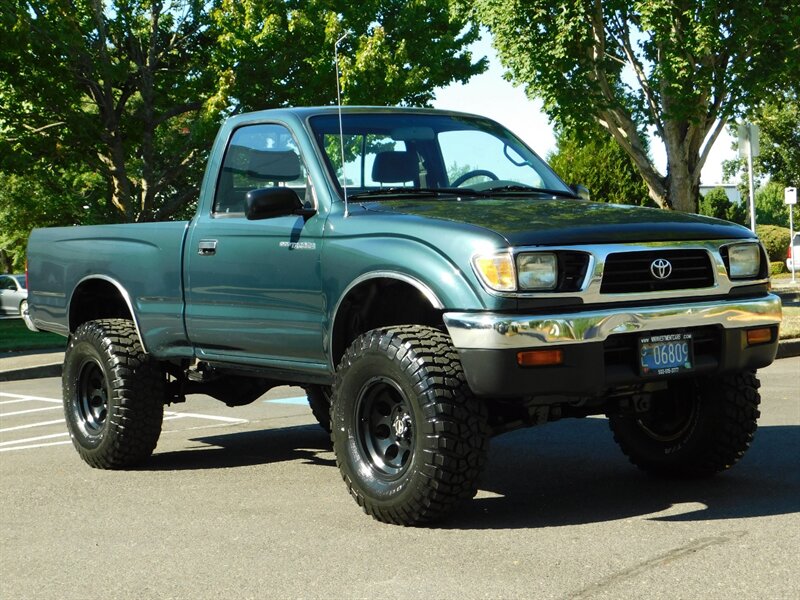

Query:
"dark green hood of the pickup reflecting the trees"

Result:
[[365, 197, 754, 246]]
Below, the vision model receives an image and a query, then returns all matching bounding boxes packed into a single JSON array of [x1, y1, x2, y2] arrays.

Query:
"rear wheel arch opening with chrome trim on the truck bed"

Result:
[[67, 275, 147, 353]]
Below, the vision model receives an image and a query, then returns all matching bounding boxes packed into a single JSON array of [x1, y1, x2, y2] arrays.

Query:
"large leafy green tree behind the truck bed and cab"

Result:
[[0, 0, 485, 268]]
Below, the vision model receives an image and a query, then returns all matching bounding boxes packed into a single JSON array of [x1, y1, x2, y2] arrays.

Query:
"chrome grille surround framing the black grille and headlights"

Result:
[[473, 239, 769, 304]]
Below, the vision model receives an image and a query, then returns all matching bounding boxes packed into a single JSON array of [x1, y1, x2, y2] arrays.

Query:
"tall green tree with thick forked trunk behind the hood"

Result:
[[460, 0, 800, 211]]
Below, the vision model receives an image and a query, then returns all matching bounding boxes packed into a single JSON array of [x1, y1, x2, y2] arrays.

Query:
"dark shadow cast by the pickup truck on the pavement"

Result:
[[140, 419, 800, 529]]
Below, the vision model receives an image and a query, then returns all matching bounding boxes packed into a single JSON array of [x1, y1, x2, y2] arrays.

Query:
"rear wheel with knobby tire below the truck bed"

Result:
[[62, 319, 165, 469]]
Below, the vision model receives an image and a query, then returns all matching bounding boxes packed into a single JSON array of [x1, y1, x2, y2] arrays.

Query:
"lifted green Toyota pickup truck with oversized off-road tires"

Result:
[[26, 107, 781, 525]]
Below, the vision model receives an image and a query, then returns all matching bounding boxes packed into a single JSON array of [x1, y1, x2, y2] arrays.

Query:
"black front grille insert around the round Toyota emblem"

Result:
[[600, 250, 714, 294]]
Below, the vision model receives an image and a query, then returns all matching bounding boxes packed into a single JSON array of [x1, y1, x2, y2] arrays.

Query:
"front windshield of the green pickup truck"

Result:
[[309, 112, 575, 200]]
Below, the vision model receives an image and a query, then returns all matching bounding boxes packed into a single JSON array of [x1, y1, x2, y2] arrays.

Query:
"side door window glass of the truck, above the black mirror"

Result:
[[214, 125, 314, 214]]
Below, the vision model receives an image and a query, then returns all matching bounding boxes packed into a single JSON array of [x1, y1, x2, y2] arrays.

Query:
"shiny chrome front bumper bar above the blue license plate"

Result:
[[444, 294, 781, 350]]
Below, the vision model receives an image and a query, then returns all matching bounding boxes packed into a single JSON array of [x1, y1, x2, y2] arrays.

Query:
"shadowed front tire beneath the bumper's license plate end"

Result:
[[609, 371, 761, 477]]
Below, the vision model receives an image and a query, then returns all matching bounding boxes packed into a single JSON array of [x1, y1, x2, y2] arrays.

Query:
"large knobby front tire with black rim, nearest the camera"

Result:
[[331, 325, 489, 525]]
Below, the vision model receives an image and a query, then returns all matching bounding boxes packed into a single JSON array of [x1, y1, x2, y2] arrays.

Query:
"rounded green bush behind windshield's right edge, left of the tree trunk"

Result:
[[547, 126, 651, 206]]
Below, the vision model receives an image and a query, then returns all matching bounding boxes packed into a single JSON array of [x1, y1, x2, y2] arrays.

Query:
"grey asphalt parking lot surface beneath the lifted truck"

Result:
[[0, 358, 800, 600]]
